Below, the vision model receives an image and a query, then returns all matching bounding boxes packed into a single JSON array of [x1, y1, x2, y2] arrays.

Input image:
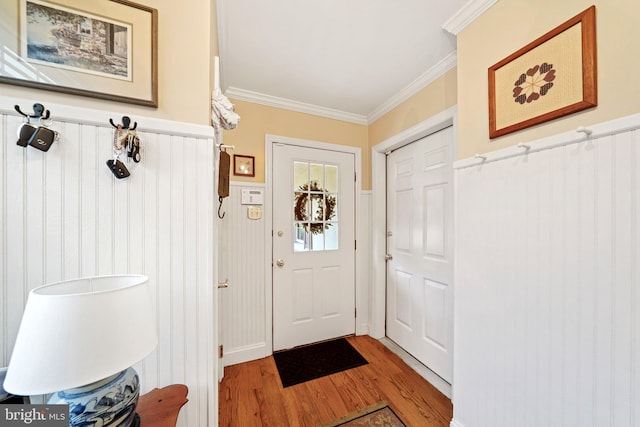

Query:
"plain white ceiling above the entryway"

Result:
[[217, 0, 495, 123]]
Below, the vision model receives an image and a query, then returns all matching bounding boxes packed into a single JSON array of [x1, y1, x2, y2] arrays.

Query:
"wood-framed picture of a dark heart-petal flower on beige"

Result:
[[489, 6, 598, 138]]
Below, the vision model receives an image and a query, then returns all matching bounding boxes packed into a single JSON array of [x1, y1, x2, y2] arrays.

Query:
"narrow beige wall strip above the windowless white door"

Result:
[[369, 68, 457, 148]]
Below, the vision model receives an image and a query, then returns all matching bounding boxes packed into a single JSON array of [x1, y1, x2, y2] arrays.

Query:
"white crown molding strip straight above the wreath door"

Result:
[[225, 87, 368, 125]]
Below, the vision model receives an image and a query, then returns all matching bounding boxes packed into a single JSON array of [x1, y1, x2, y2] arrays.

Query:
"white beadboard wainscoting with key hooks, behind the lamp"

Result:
[[0, 97, 218, 427]]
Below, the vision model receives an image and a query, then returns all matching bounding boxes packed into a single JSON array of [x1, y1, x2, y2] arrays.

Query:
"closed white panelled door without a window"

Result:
[[387, 127, 453, 383]]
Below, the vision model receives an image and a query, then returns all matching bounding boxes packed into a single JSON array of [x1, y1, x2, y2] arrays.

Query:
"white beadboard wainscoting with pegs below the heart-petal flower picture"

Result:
[[451, 115, 640, 427]]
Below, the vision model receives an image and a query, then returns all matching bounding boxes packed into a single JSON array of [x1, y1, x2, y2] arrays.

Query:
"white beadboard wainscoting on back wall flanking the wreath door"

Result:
[[218, 181, 371, 366]]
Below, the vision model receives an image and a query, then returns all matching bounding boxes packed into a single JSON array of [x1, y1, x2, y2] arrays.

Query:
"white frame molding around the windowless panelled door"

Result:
[[369, 105, 458, 339]]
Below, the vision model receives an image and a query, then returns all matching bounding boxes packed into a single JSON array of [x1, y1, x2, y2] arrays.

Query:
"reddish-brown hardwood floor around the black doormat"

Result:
[[219, 336, 453, 427]]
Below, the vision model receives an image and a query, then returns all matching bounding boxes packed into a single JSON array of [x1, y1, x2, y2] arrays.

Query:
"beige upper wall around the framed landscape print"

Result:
[[0, 0, 218, 126]]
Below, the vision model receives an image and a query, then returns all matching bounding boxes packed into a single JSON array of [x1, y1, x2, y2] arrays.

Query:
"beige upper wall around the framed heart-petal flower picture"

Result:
[[458, 0, 640, 158]]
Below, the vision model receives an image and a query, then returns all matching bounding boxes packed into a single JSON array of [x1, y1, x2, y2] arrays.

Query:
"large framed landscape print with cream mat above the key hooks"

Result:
[[0, 0, 158, 108]]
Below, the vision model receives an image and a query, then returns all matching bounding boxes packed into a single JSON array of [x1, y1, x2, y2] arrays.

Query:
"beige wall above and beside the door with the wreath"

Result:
[[223, 100, 371, 189]]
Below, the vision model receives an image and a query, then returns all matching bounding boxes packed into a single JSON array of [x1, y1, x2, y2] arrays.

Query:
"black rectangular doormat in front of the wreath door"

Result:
[[273, 338, 369, 387]]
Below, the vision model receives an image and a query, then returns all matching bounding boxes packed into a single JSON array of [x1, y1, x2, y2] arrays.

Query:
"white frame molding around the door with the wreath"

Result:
[[264, 134, 368, 356]]
